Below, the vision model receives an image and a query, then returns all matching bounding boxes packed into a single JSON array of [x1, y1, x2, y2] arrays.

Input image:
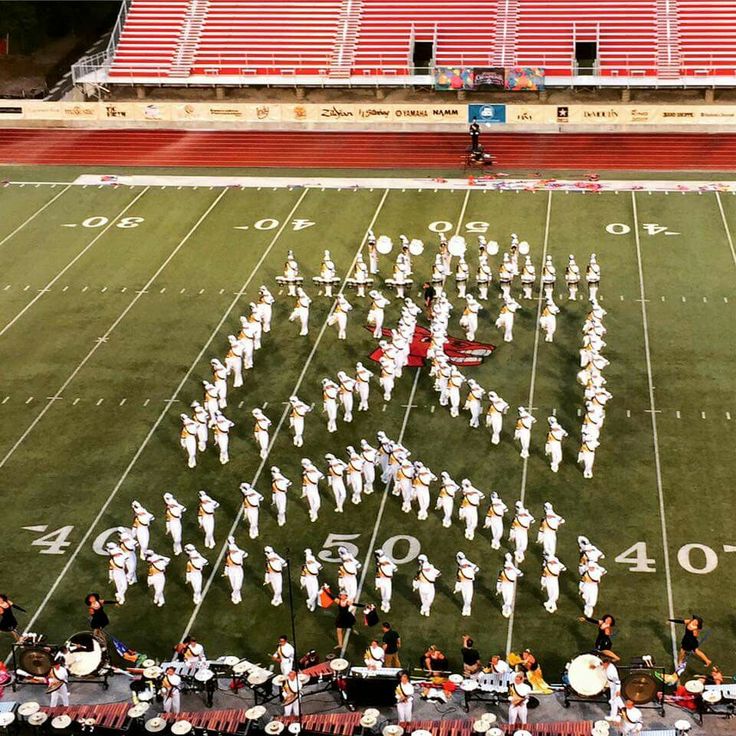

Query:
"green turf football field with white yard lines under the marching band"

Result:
[[0, 170, 736, 681]]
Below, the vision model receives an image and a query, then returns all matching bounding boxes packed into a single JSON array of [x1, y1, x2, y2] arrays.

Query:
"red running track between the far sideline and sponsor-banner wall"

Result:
[[0, 128, 736, 171]]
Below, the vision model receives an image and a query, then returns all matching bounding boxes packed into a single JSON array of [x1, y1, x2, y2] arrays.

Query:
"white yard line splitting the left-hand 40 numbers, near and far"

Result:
[[10, 189, 309, 648]]
